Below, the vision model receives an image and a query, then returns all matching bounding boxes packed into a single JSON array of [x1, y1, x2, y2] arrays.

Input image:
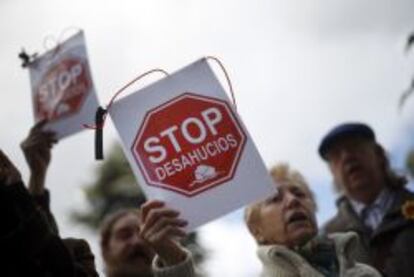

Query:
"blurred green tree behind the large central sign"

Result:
[[72, 144, 206, 268]]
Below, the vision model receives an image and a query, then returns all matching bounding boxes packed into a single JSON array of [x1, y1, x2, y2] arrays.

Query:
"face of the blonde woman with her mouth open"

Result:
[[256, 182, 317, 247]]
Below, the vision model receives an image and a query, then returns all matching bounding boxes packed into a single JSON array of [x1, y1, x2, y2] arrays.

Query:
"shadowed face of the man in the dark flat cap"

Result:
[[326, 136, 384, 204]]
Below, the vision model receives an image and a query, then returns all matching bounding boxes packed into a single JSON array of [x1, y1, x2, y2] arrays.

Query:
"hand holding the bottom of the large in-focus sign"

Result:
[[140, 200, 188, 266]]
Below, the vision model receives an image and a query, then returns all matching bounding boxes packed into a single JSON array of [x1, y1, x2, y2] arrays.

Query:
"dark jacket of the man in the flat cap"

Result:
[[323, 188, 414, 277]]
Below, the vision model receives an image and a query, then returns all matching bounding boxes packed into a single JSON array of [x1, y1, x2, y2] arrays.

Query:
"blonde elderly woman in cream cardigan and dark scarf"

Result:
[[245, 164, 381, 277]]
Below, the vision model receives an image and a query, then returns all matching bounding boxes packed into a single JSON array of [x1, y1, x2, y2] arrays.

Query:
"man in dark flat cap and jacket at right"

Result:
[[319, 123, 414, 277]]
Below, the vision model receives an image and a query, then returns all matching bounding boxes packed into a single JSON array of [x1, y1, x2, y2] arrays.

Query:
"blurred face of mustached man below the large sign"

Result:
[[105, 213, 154, 276]]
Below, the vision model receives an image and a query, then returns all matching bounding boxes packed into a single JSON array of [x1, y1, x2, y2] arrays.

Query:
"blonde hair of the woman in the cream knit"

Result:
[[244, 163, 317, 244]]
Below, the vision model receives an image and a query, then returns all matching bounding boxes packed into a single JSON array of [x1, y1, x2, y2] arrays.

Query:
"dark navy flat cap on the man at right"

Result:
[[318, 123, 375, 160]]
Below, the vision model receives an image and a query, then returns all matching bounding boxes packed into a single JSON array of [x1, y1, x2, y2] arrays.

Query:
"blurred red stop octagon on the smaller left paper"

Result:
[[34, 58, 91, 121]]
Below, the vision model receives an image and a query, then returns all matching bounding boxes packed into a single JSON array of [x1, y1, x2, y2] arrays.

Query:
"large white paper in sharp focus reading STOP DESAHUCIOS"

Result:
[[109, 59, 275, 230]]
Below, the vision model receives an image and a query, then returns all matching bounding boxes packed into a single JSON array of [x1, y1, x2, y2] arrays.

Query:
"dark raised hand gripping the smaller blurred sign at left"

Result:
[[20, 120, 57, 194]]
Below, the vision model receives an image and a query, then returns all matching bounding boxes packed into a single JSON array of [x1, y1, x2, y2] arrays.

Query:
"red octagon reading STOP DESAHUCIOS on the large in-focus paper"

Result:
[[131, 93, 246, 196]]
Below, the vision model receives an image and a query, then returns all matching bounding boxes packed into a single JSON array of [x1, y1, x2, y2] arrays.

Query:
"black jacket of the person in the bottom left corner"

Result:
[[0, 180, 97, 277]]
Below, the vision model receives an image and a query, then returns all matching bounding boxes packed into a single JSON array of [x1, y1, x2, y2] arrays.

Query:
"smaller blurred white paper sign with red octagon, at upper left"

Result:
[[29, 32, 99, 139]]
